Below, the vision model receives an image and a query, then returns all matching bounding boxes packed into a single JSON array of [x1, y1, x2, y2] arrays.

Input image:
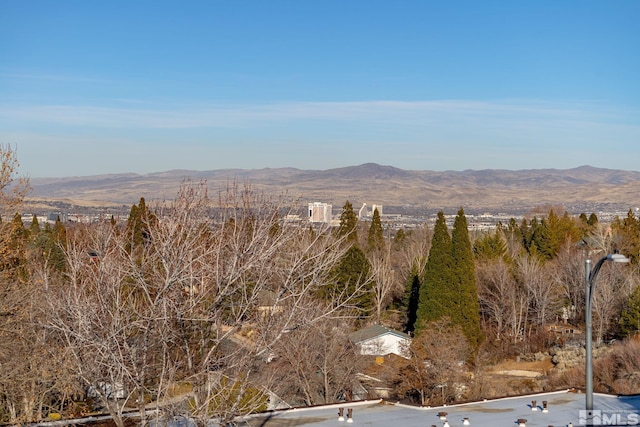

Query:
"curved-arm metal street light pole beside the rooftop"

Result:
[[584, 254, 629, 425]]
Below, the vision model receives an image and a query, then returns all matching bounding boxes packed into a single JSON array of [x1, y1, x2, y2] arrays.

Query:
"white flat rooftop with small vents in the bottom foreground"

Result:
[[238, 391, 640, 427]]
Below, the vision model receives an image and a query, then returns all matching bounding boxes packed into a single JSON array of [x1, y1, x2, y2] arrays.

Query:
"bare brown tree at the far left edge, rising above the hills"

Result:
[[0, 144, 61, 423]]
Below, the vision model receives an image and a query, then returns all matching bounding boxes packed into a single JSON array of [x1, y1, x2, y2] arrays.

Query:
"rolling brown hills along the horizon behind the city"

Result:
[[29, 163, 640, 217]]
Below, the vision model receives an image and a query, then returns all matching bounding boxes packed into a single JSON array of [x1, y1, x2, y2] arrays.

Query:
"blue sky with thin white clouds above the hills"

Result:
[[0, 0, 640, 177]]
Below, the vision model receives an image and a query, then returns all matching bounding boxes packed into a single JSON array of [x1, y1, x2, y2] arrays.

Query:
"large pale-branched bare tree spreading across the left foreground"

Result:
[[52, 183, 363, 425]]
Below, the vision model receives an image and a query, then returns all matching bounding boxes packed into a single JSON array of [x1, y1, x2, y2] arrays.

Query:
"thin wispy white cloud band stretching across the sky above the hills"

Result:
[[0, 100, 639, 129]]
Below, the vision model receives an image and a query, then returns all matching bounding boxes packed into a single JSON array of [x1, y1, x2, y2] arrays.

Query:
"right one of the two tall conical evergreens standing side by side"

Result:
[[449, 208, 482, 348]]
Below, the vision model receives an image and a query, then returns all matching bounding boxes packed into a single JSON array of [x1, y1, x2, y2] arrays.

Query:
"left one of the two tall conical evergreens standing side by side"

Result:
[[416, 211, 454, 333]]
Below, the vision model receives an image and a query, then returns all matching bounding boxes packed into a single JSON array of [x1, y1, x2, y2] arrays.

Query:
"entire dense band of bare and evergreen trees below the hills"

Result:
[[0, 146, 640, 426]]
